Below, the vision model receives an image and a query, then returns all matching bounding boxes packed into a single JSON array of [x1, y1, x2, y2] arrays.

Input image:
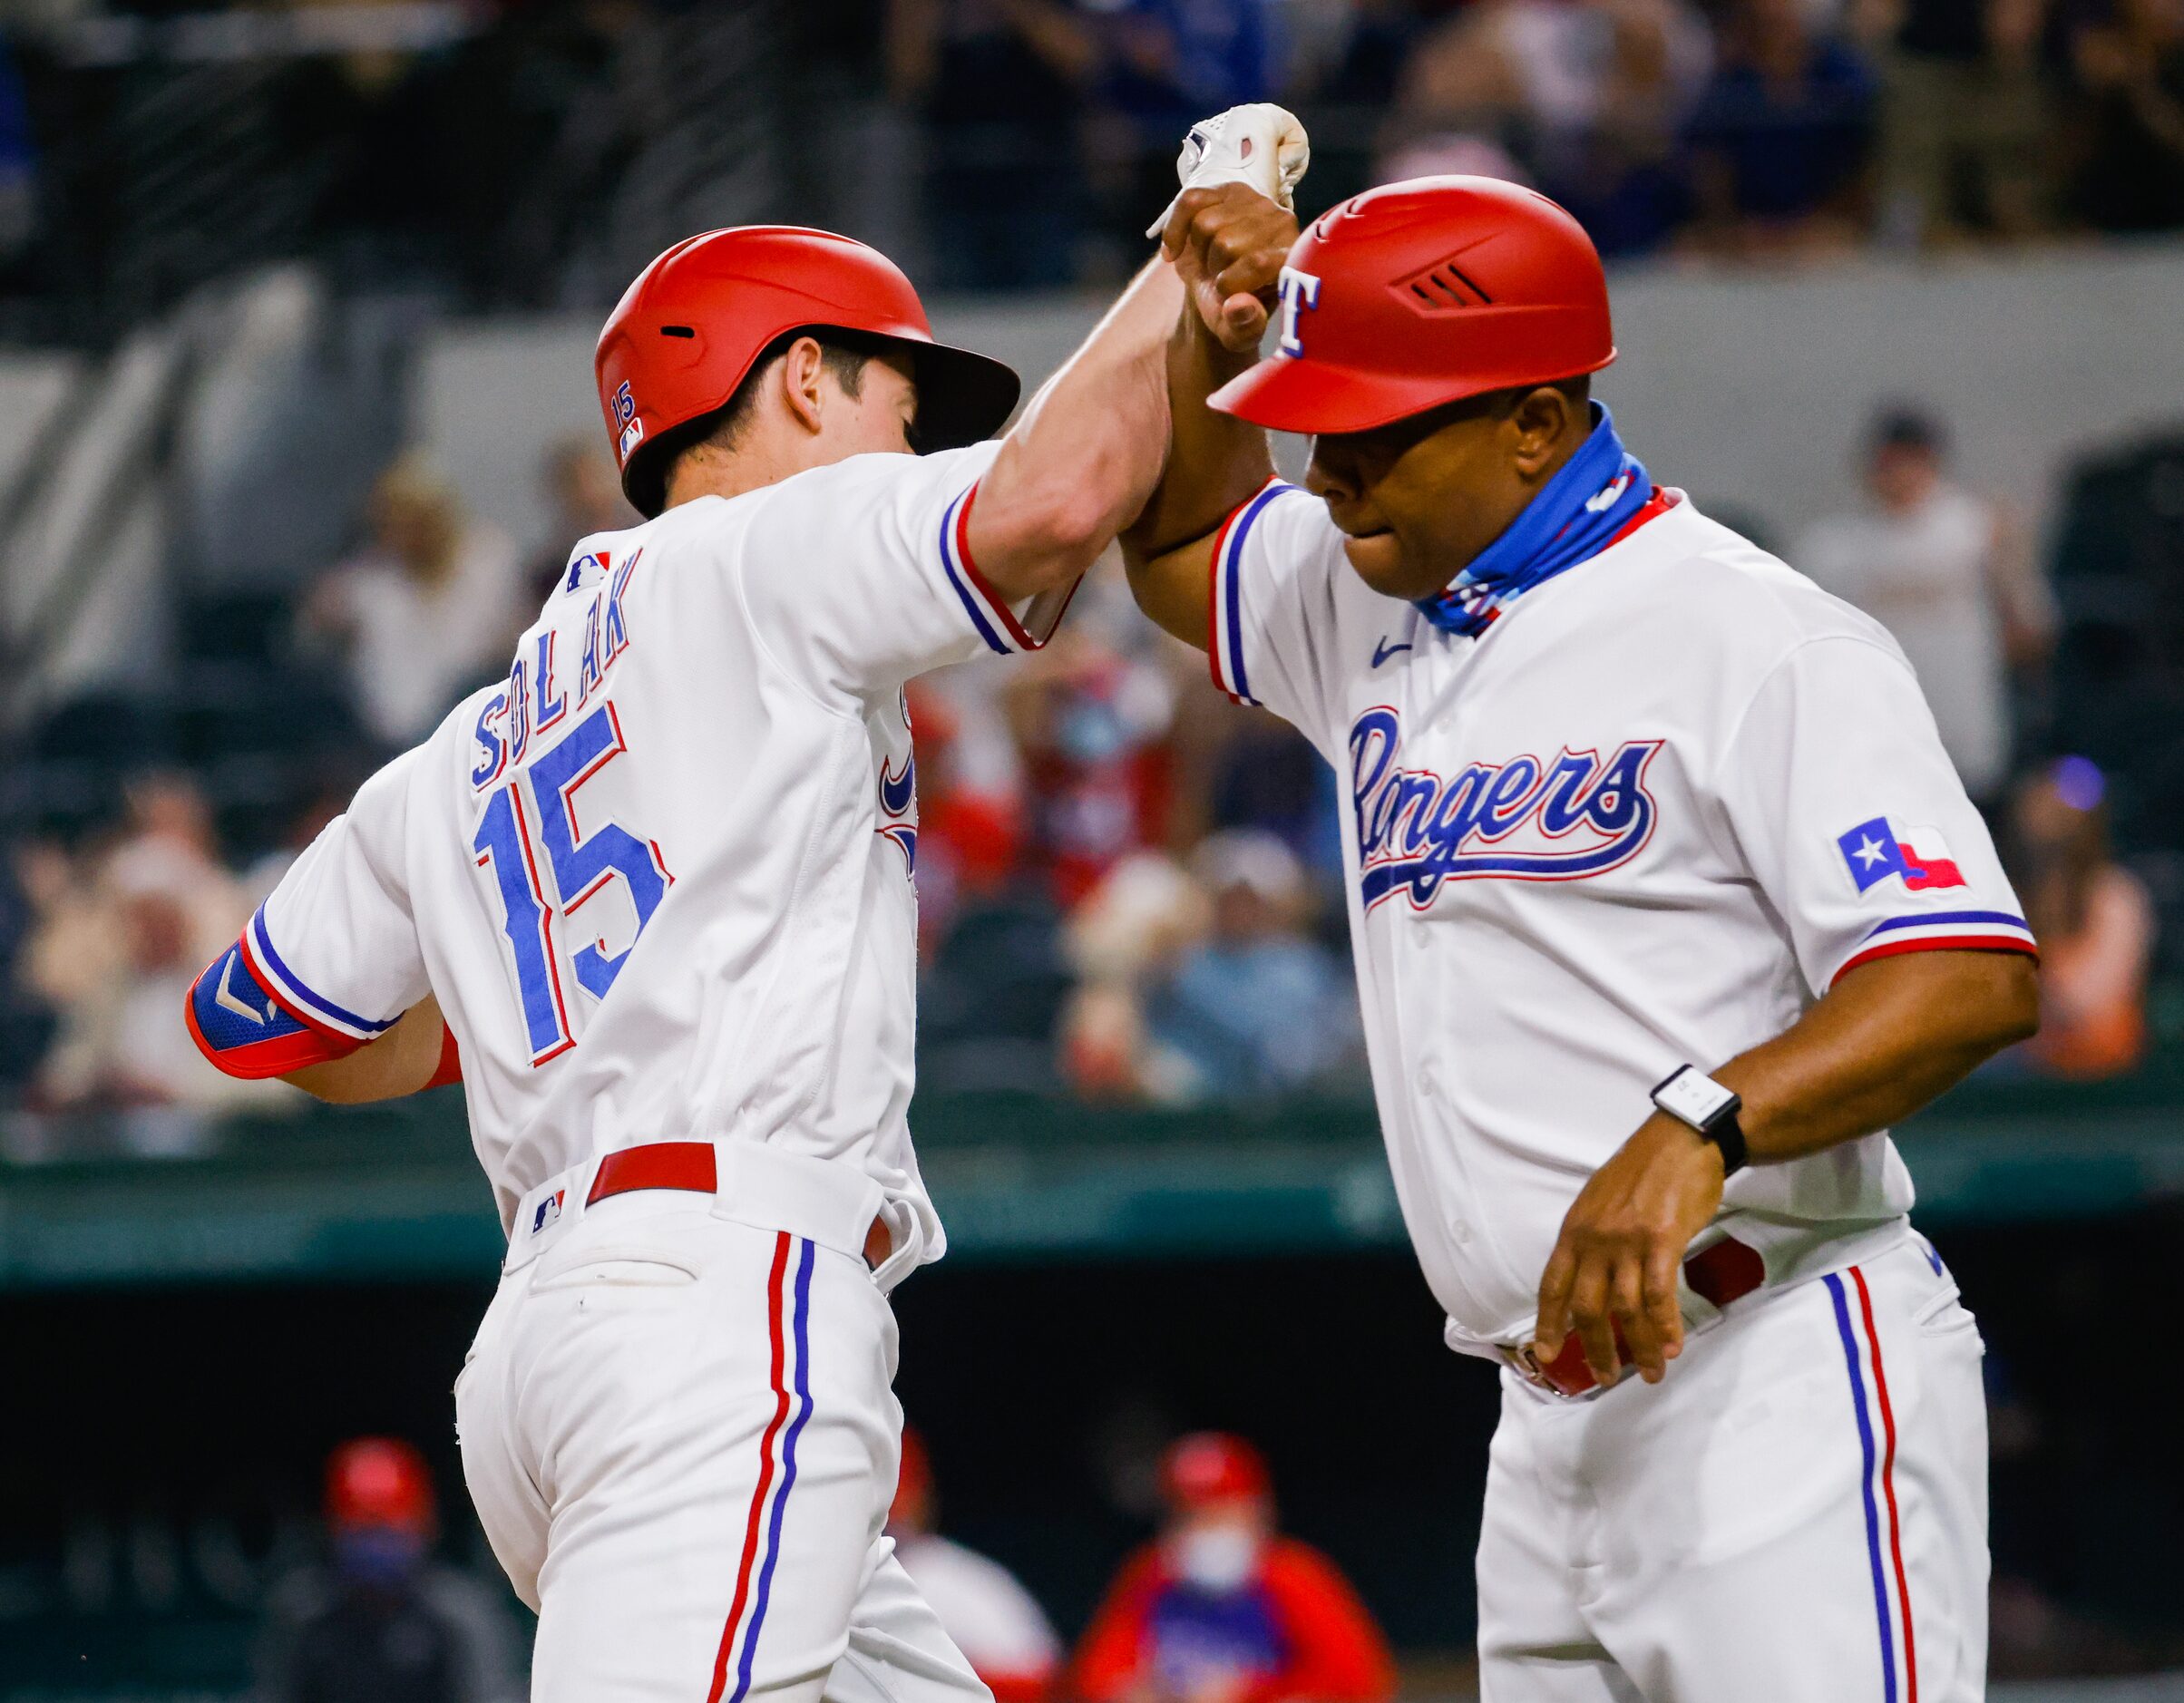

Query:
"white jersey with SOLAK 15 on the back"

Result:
[[199, 443, 1052, 1260]]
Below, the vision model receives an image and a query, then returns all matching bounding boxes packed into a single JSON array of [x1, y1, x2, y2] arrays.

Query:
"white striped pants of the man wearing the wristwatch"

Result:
[[1478, 1236, 1987, 1703]]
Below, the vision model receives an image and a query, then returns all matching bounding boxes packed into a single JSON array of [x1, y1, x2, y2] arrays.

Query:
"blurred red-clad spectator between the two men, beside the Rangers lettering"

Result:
[[1005, 622, 1175, 910]]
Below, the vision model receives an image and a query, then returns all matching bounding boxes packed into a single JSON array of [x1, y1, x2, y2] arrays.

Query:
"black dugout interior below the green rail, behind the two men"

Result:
[[0, 1212, 2184, 1686]]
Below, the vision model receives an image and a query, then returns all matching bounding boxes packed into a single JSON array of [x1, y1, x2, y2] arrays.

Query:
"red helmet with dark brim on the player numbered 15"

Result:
[[592, 225, 1022, 515]]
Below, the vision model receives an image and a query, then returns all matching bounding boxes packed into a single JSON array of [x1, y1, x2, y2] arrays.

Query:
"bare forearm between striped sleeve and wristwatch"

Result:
[[1710, 952, 2040, 1163]]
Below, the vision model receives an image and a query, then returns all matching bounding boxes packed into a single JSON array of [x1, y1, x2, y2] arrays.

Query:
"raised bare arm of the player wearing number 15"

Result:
[[970, 260, 1184, 598]]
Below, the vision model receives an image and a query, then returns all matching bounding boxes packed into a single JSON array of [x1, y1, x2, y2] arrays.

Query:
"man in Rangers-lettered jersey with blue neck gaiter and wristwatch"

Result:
[[1125, 152, 2035, 1703]]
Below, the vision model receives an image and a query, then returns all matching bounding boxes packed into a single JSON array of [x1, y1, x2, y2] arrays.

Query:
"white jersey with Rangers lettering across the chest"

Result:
[[1210, 482, 2033, 1351]]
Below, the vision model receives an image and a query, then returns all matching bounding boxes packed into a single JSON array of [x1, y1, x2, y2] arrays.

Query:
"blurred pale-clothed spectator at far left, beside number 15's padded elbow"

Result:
[[24, 775, 277, 1144]]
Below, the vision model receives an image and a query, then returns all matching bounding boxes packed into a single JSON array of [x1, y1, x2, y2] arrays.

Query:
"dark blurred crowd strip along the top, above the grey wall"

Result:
[[0, 0, 2184, 334]]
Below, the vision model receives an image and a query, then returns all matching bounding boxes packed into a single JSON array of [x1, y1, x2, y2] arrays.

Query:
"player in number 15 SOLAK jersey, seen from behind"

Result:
[[188, 193, 1292, 1703]]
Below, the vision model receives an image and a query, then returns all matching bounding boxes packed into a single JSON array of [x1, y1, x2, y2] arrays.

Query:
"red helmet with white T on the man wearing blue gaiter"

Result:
[[1212, 177, 1616, 433]]
